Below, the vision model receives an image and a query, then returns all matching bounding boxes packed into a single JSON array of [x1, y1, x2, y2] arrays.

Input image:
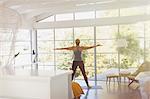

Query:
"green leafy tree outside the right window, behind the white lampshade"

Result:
[[115, 31, 144, 68]]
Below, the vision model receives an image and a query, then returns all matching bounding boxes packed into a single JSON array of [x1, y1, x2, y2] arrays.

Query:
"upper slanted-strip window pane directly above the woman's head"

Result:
[[75, 11, 95, 20]]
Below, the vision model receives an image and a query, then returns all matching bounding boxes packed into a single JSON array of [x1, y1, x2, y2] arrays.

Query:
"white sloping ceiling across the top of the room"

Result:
[[0, 0, 150, 21]]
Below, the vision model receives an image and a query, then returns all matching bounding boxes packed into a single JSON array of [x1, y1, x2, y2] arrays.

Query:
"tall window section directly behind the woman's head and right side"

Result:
[[74, 27, 94, 79]]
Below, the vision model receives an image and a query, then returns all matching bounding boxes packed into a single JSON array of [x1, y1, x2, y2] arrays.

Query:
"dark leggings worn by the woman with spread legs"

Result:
[[72, 61, 89, 86]]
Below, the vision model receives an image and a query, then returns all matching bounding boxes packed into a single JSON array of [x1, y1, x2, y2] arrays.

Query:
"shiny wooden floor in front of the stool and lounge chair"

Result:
[[81, 82, 142, 99]]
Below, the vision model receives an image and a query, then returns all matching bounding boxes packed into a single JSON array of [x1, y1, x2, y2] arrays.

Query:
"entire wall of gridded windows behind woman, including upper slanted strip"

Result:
[[35, 6, 150, 80]]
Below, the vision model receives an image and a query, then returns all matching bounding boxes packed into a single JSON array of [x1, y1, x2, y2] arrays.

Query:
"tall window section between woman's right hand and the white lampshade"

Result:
[[96, 25, 118, 80]]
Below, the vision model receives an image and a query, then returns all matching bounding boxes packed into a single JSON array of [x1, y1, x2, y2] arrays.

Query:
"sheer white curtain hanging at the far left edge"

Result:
[[0, 6, 21, 73]]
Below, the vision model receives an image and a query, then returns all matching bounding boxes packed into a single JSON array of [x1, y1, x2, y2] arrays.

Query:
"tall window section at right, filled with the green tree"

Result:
[[116, 23, 144, 76]]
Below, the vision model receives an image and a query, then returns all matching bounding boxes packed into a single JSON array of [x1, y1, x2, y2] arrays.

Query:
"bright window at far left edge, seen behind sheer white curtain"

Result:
[[0, 28, 15, 66]]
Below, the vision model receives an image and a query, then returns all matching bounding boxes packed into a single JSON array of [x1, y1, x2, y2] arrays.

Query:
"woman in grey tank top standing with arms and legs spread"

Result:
[[55, 39, 101, 88]]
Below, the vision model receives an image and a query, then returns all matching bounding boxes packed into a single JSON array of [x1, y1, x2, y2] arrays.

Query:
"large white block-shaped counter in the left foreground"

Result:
[[0, 70, 72, 99]]
